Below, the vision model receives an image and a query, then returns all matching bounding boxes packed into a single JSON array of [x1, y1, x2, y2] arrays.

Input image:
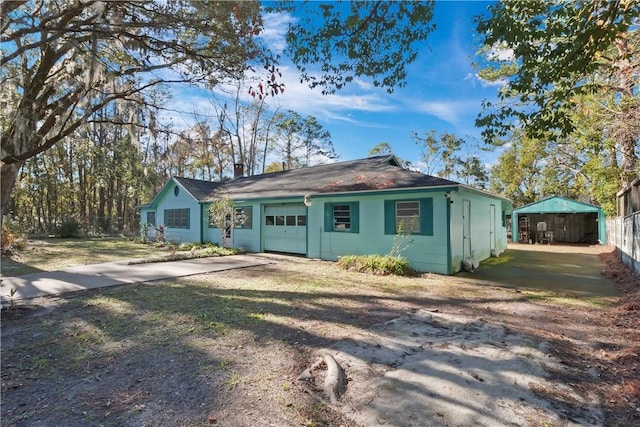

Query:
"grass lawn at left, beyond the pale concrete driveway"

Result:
[[0, 237, 167, 277]]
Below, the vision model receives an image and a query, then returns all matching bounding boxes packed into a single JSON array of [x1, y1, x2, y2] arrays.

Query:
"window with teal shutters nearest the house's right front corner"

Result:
[[384, 198, 433, 236]]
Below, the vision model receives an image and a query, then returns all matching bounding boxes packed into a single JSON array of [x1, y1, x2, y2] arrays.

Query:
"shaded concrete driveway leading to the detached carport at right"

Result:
[[458, 245, 620, 297]]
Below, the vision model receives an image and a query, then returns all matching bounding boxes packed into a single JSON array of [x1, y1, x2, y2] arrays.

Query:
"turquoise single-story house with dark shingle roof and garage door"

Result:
[[138, 155, 512, 274]]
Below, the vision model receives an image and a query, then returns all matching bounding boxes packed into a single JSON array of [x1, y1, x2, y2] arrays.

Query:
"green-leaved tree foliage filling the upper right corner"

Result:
[[476, 0, 640, 185]]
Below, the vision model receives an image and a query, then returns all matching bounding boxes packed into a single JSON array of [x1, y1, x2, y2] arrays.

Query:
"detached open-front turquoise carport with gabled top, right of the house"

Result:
[[511, 196, 607, 244]]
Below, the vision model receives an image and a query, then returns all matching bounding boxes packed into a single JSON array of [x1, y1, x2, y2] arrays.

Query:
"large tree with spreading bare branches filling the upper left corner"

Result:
[[0, 0, 268, 212]]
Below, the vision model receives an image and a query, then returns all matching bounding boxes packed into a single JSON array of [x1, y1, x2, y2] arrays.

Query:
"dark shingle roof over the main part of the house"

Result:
[[204, 156, 458, 200]]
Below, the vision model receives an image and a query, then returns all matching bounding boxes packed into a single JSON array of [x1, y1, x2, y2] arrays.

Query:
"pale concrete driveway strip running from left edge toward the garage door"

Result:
[[0, 255, 272, 305]]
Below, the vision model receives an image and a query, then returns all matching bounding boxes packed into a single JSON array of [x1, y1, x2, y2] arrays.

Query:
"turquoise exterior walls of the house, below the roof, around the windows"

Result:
[[141, 180, 511, 274]]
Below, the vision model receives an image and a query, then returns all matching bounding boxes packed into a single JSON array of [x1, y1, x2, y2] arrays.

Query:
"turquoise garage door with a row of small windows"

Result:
[[263, 205, 307, 254]]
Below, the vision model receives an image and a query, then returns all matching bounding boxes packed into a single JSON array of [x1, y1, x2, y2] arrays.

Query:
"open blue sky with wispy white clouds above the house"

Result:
[[169, 1, 499, 172]]
